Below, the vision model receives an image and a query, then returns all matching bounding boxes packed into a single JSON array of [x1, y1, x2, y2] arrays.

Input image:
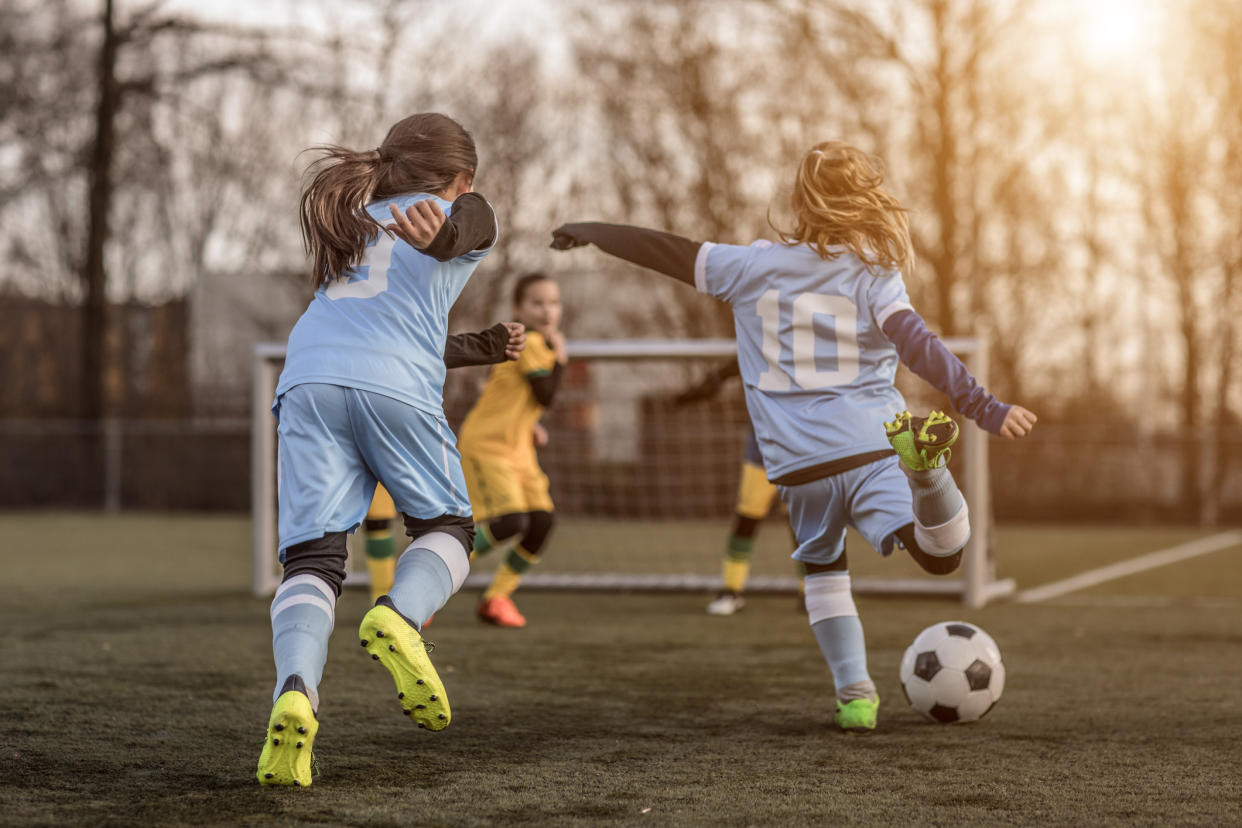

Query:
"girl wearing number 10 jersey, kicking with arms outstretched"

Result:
[[553, 142, 1036, 732]]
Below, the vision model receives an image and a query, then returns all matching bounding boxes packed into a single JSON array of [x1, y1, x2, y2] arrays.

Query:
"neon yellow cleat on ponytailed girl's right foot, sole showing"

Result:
[[358, 596, 452, 730]]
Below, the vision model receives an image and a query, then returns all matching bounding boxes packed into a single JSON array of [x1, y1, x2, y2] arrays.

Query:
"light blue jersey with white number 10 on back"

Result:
[[694, 241, 912, 480]]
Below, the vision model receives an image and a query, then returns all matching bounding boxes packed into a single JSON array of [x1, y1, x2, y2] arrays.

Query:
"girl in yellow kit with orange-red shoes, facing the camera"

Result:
[[457, 273, 569, 627]]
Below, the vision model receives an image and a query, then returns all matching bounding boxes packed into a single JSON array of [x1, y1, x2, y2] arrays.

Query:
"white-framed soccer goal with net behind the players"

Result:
[[252, 339, 1015, 607]]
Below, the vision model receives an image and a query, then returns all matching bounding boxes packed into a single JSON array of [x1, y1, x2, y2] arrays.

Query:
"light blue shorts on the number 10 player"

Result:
[[779, 454, 914, 564]]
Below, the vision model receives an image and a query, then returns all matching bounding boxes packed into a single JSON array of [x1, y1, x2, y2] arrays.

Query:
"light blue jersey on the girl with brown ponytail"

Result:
[[276, 194, 491, 416]]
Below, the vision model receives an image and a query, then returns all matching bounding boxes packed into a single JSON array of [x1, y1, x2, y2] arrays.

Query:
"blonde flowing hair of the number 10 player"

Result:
[[769, 142, 914, 273]]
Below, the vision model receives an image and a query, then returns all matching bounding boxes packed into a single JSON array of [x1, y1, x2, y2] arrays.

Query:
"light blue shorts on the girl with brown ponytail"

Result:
[[276, 382, 471, 561]]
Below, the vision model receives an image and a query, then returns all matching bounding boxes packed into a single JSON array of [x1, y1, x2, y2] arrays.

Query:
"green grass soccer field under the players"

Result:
[[0, 514, 1242, 826]]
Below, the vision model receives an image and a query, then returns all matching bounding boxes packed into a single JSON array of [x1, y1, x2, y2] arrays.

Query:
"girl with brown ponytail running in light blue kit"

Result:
[[257, 113, 497, 786]]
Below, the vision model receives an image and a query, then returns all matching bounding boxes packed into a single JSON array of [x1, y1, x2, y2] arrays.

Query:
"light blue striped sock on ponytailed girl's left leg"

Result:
[[272, 575, 337, 710]]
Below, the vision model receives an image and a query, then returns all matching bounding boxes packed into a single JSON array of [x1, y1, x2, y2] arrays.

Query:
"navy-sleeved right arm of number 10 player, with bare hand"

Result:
[[884, 310, 1036, 438]]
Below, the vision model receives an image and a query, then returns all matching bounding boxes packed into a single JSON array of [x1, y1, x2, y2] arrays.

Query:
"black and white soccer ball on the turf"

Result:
[[902, 621, 1005, 724]]
